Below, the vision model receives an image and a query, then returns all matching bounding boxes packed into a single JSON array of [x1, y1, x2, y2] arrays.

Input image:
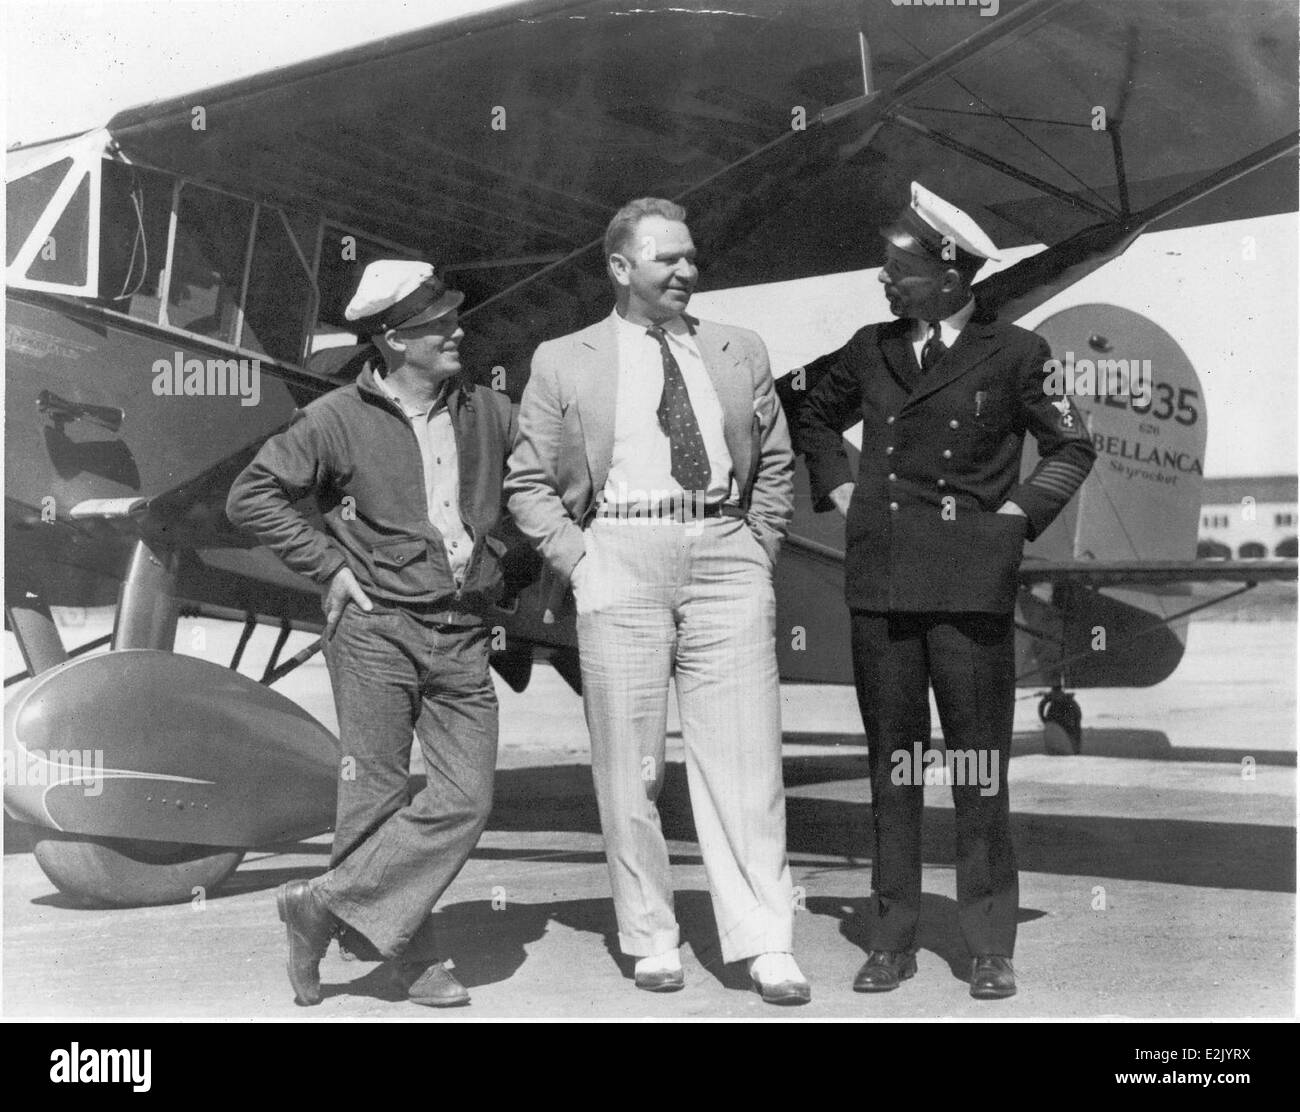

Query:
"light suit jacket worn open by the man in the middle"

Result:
[[506, 316, 794, 614]]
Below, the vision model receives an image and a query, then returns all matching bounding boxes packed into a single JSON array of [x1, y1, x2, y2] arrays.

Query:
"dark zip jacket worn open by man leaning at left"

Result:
[[226, 367, 515, 611]]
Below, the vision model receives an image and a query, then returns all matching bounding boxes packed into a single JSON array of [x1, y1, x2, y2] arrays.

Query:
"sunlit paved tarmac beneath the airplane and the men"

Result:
[[3, 600, 1296, 1022]]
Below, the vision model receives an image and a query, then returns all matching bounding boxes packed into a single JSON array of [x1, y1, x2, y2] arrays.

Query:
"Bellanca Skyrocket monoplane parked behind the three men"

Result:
[[4, 0, 1300, 905]]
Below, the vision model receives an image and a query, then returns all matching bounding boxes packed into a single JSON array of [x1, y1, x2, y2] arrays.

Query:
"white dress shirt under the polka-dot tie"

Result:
[[605, 310, 735, 509]]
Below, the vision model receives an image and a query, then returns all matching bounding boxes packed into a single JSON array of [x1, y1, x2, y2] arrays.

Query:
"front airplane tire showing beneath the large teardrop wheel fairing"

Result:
[[33, 830, 244, 908]]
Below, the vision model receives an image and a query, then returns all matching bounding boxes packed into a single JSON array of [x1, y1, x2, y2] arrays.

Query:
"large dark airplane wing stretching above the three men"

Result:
[[101, 0, 1297, 395]]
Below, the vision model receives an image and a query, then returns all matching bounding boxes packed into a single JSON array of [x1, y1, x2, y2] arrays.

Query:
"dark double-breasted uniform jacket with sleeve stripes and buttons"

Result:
[[794, 319, 1096, 614]]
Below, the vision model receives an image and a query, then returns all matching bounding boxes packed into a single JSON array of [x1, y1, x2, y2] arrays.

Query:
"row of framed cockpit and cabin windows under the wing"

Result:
[[5, 145, 351, 365]]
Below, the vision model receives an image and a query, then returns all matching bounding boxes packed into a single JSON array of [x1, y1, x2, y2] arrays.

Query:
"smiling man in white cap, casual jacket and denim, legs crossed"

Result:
[[226, 259, 514, 1007]]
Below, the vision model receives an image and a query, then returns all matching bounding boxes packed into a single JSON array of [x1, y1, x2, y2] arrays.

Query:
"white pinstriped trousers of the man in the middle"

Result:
[[575, 518, 794, 961]]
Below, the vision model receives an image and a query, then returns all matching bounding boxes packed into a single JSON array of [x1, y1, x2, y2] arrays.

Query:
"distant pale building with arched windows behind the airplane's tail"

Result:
[[1196, 475, 1300, 559]]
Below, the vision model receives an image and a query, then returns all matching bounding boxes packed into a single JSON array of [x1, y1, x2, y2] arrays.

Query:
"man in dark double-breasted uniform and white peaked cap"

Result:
[[794, 183, 1096, 998]]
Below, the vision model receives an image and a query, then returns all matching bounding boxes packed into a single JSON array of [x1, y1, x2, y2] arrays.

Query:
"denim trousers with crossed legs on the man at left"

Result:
[[313, 602, 497, 961]]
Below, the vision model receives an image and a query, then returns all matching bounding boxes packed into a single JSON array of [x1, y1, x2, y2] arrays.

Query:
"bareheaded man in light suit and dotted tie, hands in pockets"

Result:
[[506, 198, 810, 1004]]
